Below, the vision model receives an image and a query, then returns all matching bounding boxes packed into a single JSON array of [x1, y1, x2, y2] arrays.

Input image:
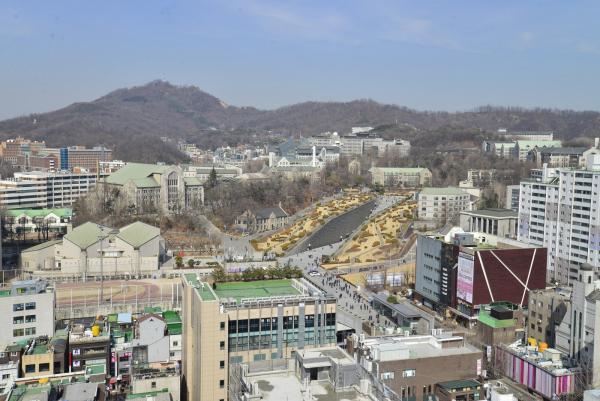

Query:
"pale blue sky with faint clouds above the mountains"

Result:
[[0, 0, 600, 119]]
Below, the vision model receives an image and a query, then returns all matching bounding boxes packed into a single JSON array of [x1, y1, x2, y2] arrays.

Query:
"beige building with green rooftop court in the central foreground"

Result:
[[182, 273, 336, 401]]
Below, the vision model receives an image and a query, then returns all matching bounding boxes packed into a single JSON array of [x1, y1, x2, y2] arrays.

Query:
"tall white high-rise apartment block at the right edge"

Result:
[[518, 155, 600, 284]]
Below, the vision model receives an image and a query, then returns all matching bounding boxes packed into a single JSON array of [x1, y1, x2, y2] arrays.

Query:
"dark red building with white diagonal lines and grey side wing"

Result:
[[415, 228, 546, 323]]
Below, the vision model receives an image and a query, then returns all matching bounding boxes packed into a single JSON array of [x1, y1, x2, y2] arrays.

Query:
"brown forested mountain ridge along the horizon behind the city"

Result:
[[0, 81, 600, 162]]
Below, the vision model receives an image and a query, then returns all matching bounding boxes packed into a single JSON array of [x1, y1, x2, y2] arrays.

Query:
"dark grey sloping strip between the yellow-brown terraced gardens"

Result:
[[292, 199, 377, 254]]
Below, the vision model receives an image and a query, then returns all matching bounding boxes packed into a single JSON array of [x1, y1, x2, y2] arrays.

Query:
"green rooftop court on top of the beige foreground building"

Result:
[[215, 280, 300, 303]]
